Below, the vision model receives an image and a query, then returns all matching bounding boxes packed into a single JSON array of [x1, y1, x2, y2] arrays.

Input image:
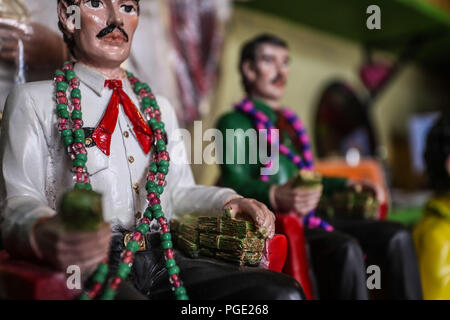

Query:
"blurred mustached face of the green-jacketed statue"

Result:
[[244, 44, 290, 100]]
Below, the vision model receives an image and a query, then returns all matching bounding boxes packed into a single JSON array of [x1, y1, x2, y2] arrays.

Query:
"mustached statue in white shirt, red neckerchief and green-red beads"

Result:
[[0, 0, 303, 300]]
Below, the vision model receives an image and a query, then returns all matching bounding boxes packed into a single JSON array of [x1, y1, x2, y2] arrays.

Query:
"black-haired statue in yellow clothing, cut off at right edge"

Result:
[[414, 114, 450, 300]]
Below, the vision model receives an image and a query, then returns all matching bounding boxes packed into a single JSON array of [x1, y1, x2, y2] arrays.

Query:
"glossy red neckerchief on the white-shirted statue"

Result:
[[92, 80, 153, 156]]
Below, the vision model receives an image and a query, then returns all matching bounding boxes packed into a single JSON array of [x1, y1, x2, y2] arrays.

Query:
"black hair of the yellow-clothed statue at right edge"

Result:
[[424, 113, 450, 192]]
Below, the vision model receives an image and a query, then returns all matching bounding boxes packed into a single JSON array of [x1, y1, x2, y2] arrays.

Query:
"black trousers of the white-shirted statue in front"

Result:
[[110, 233, 304, 300]]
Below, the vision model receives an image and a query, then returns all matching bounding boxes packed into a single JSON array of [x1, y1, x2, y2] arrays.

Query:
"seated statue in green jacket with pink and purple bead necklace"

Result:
[[217, 35, 422, 299]]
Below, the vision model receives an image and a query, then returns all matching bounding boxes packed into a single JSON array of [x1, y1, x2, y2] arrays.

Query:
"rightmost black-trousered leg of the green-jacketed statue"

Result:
[[333, 220, 422, 300]]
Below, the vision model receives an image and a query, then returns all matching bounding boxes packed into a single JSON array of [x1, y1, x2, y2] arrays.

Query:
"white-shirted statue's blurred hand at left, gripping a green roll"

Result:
[[32, 216, 111, 277]]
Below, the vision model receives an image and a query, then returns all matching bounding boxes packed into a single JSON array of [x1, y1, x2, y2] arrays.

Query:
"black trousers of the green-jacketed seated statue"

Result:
[[305, 220, 422, 300]]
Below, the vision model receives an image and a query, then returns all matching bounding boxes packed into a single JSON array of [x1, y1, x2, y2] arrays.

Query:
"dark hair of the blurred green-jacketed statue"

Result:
[[239, 33, 288, 94]]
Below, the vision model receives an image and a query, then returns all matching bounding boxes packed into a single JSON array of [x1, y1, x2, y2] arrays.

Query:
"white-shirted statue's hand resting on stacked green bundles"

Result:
[[224, 198, 275, 238]]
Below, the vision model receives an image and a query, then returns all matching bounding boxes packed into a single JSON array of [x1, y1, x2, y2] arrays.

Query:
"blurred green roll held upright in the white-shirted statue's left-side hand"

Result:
[[60, 189, 103, 231]]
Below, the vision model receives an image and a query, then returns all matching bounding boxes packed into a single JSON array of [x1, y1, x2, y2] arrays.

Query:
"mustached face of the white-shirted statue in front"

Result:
[[63, 0, 139, 67]]
